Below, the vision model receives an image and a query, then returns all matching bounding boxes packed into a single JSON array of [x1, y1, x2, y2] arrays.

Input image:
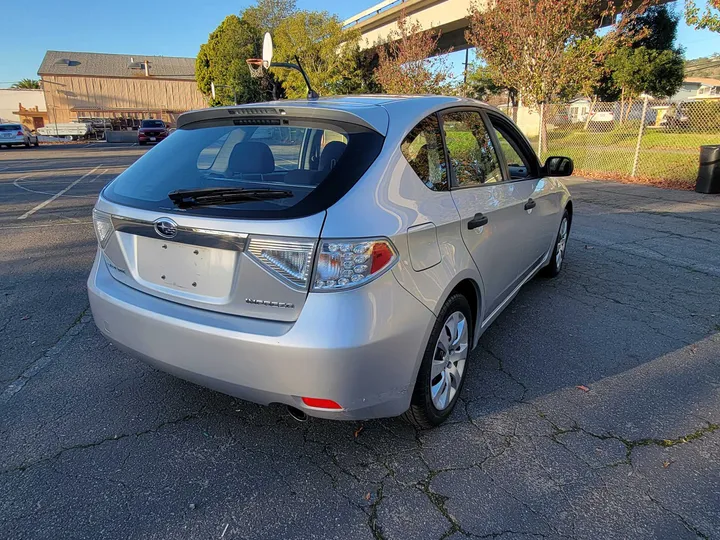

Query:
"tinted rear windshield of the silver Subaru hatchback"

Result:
[[103, 119, 384, 219]]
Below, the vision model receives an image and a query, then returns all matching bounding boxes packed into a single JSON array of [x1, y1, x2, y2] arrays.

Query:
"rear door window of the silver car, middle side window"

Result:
[[443, 111, 502, 187]]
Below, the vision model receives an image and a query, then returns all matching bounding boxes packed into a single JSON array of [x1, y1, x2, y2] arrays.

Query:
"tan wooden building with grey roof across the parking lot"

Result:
[[38, 51, 207, 129]]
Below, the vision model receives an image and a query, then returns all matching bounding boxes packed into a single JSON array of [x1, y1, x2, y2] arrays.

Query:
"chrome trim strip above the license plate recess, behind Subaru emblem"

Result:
[[111, 215, 248, 251]]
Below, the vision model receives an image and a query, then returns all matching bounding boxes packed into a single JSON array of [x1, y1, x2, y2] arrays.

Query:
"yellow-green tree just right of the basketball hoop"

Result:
[[272, 11, 362, 98]]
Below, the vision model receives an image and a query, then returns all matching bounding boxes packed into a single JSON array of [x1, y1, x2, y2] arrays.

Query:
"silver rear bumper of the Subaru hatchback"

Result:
[[88, 251, 434, 420]]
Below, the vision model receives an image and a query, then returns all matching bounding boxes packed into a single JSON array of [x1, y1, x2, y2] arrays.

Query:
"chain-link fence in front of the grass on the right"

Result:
[[510, 98, 720, 187]]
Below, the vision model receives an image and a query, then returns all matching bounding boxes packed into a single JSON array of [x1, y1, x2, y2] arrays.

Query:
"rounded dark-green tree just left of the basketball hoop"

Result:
[[195, 15, 271, 106]]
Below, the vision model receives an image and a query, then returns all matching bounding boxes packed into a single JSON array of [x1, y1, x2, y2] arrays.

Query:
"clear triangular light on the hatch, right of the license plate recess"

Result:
[[247, 237, 315, 290]]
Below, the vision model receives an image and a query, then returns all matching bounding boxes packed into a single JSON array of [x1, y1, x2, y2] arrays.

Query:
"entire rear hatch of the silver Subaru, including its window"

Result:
[[94, 109, 384, 321]]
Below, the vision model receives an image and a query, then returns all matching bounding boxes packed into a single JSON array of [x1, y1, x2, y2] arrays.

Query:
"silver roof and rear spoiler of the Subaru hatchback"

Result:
[[177, 94, 490, 135]]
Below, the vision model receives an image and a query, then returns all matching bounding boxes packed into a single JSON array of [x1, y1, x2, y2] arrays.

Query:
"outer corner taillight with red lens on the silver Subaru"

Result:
[[312, 239, 397, 291]]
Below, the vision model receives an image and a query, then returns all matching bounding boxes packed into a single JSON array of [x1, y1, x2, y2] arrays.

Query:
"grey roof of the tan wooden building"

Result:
[[38, 51, 195, 80]]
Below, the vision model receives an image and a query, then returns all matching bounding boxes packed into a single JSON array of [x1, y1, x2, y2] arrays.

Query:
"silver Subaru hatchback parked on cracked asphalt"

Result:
[[88, 96, 572, 427]]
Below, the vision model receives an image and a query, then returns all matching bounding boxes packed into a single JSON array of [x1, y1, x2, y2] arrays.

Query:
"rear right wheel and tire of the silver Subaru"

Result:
[[403, 294, 473, 429]]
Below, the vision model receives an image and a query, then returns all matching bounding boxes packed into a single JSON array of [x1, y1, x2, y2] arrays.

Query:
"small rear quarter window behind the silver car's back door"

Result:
[[401, 115, 448, 191]]
